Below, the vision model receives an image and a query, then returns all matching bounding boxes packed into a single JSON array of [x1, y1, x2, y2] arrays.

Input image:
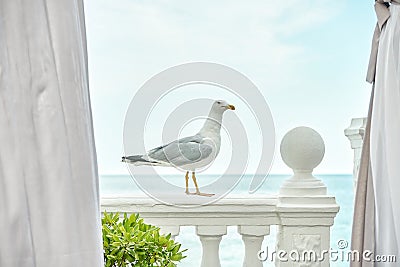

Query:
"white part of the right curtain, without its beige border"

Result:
[[370, 4, 400, 266]]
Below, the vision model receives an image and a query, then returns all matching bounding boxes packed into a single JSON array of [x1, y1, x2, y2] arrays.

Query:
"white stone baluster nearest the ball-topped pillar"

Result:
[[238, 225, 269, 267]]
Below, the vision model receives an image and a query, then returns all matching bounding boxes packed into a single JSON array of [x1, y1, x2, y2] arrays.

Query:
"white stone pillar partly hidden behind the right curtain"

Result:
[[344, 118, 367, 190]]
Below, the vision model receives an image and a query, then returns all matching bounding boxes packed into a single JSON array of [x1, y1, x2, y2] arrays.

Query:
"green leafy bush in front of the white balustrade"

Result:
[[102, 212, 186, 267]]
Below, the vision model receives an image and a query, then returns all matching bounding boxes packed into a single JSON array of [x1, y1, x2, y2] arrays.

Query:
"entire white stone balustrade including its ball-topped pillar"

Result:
[[101, 127, 339, 267]]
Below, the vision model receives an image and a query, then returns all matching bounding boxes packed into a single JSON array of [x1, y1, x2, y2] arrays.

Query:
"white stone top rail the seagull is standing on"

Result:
[[101, 194, 279, 225]]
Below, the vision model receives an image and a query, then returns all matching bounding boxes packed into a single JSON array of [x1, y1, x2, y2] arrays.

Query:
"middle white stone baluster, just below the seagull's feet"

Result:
[[196, 226, 226, 267]]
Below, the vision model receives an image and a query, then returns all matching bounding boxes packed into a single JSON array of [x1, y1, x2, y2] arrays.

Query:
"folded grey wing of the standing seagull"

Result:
[[147, 135, 213, 166]]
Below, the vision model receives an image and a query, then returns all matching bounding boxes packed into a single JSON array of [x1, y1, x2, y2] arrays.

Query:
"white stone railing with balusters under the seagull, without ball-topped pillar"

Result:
[[101, 195, 279, 267]]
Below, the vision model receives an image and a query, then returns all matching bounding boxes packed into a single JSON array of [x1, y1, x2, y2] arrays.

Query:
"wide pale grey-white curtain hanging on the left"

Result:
[[0, 0, 103, 267]]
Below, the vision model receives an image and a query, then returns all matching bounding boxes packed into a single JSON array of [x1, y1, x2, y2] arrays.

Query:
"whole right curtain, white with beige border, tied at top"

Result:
[[351, 0, 400, 267]]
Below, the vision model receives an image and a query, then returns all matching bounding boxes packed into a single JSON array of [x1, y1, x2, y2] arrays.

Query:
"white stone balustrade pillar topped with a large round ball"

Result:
[[275, 127, 339, 267]]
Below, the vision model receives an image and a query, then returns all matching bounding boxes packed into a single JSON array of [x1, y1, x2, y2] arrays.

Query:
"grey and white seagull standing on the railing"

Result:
[[122, 100, 235, 197]]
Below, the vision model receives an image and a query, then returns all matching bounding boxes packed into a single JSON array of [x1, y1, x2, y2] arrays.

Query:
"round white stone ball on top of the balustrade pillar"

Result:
[[280, 126, 325, 172]]
